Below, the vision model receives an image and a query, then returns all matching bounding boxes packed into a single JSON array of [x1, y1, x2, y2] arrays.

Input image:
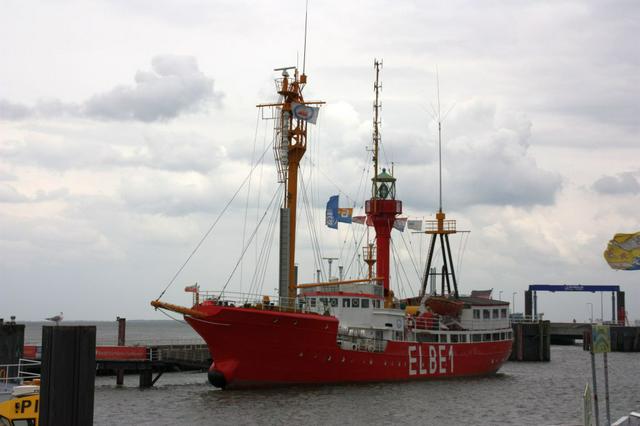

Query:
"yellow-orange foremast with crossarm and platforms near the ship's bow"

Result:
[[258, 67, 324, 299]]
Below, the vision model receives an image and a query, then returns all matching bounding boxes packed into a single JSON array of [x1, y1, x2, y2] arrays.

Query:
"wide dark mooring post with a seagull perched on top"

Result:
[[39, 326, 96, 426]]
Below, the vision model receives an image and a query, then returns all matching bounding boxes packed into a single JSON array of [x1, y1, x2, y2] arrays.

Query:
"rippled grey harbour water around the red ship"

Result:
[[25, 321, 640, 425]]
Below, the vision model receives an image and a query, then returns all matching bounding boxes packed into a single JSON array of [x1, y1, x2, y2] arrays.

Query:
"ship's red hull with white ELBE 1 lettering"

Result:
[[186, 306, 511, 388]]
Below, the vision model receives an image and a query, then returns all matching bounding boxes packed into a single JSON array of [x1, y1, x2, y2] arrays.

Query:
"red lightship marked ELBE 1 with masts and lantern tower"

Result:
[[151, 62, 512, 388]]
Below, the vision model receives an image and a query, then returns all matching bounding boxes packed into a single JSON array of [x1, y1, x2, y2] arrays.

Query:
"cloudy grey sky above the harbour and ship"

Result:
[[0, 0, 640, 321]]
